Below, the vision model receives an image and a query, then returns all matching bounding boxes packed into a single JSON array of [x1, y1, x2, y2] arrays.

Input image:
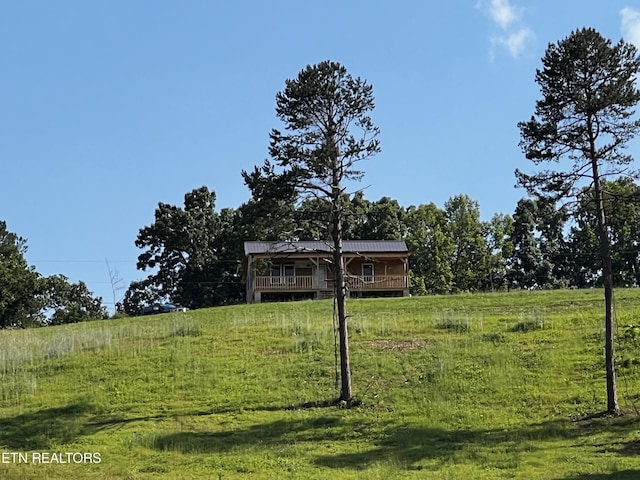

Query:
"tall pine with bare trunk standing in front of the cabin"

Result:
[[248, 61, 380, 403]]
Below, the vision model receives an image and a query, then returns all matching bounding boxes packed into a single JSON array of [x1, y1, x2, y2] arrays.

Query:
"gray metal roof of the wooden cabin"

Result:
[[244, 240, 409, 255]]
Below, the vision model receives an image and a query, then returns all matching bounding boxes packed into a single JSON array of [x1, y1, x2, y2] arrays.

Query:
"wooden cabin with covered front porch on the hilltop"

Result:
[[243, 240, 409, 303]]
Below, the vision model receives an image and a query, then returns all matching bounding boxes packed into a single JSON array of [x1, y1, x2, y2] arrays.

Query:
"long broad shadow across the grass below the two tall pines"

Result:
[[144, 415, 638, 479]]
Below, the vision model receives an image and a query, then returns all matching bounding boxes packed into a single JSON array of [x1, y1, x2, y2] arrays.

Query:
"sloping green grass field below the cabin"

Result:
[[0, 290, 640, 480]]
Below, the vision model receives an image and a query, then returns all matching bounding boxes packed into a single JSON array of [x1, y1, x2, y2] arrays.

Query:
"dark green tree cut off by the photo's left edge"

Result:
[[0, 221, 42, 328]]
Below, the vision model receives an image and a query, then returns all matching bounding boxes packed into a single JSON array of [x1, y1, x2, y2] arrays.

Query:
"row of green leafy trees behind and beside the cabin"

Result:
[[122, 174, 640, 314]]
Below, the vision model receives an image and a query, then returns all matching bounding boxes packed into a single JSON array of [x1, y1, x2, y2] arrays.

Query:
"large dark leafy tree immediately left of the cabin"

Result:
[[129, 187, 241, 314]]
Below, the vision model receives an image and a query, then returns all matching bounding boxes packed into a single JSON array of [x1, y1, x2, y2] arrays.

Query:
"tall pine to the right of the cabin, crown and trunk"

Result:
[[516, 28, 640, 413]]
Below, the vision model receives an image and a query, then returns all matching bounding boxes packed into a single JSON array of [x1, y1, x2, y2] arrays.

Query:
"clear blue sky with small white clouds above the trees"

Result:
[[0, 0, 640, 309]]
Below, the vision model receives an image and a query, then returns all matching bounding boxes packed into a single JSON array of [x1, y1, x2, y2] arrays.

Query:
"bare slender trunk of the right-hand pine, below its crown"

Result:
[[592, 168, 620, 414]]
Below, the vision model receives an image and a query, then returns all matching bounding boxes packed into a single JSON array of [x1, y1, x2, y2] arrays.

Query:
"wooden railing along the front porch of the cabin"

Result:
[[254, 275, 409, 292]]
